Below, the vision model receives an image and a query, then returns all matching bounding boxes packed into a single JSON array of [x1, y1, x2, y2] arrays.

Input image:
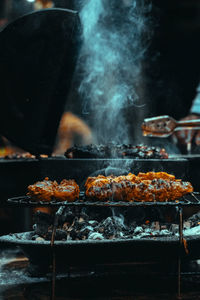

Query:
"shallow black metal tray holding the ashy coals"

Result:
[[0, 232, 200, 266]]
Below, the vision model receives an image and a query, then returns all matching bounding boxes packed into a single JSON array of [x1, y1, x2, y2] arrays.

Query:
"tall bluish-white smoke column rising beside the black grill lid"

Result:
[[79, 0, 151, 144]]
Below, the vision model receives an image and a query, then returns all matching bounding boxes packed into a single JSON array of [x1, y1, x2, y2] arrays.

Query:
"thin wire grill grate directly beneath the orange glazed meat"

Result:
[[7, 192, 200, 207]]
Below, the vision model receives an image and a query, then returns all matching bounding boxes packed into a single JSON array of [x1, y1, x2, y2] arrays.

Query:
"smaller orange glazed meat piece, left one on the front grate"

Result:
[[27, 177, 80, 202]]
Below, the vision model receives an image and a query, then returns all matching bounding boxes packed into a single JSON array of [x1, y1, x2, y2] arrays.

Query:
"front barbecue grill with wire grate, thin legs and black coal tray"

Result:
[[0, 189, 200, 296]]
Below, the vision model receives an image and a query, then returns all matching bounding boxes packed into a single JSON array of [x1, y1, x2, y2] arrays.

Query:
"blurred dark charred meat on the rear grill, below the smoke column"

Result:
[[65, 143, 168, 159]]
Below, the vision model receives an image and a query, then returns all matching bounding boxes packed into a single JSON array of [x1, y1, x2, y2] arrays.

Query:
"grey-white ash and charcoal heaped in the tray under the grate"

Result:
[[32, 208, 200, 241]]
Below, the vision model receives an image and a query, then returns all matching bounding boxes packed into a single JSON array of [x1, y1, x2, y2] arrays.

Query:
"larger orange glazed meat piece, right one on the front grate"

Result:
[[85, 172, 193, 202]]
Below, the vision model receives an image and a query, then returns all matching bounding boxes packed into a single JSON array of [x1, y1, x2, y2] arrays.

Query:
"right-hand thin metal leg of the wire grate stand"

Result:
[[177, 207, 183, 299]]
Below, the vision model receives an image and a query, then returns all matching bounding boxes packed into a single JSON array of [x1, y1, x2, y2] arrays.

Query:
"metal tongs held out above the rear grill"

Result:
[[142, 116, 200, 138]]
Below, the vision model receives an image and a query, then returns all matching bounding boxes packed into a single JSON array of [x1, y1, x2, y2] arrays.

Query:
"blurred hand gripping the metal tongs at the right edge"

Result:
[[172, 114, 200, 146]]
